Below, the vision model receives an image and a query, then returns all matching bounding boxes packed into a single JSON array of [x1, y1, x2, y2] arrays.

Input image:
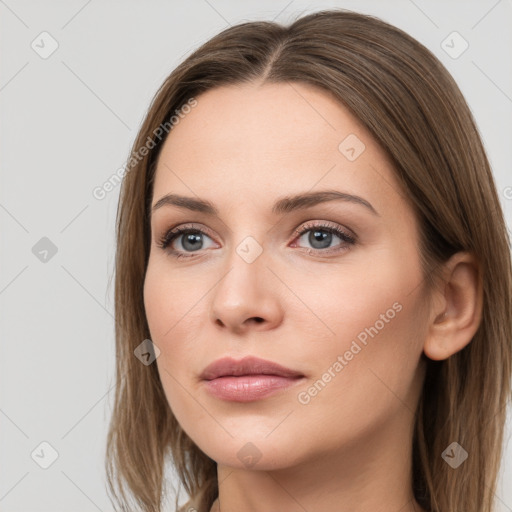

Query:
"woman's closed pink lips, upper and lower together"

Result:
[[200, 356, 304, 402]]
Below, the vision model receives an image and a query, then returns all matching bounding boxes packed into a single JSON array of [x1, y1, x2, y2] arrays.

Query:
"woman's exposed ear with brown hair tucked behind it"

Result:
[[423, 252, 483, 360]]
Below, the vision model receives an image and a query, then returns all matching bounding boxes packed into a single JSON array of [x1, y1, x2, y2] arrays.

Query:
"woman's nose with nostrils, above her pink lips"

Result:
[[211, 250, 284, 334]]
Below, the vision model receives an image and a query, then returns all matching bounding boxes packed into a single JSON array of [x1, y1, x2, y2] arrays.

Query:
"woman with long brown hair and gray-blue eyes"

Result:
[[107, 10, 512, 512]]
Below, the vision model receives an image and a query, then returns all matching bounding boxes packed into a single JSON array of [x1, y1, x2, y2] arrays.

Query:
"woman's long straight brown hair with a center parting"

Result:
[[106, 9, 512, 512]]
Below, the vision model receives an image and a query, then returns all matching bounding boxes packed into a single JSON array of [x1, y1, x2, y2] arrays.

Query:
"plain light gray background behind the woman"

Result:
[[0, 0, 512, 512]]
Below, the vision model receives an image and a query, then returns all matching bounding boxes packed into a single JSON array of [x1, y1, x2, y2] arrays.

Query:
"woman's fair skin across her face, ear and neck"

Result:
[[144, 83, 481, 512]]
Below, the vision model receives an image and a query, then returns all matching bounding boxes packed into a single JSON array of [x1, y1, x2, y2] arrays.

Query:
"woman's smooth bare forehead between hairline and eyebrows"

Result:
[[153, 83, 399, 214]]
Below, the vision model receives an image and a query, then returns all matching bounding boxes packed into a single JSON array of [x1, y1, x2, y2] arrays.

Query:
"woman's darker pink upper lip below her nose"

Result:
[[200, 356, 304, 380]]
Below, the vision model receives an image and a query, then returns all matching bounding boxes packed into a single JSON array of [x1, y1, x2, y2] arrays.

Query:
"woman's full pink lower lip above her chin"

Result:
[[204, 375, 302, 402]]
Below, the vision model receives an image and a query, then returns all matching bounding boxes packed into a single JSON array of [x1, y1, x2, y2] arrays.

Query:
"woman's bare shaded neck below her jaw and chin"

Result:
[[211, 408, 424, 512]]
